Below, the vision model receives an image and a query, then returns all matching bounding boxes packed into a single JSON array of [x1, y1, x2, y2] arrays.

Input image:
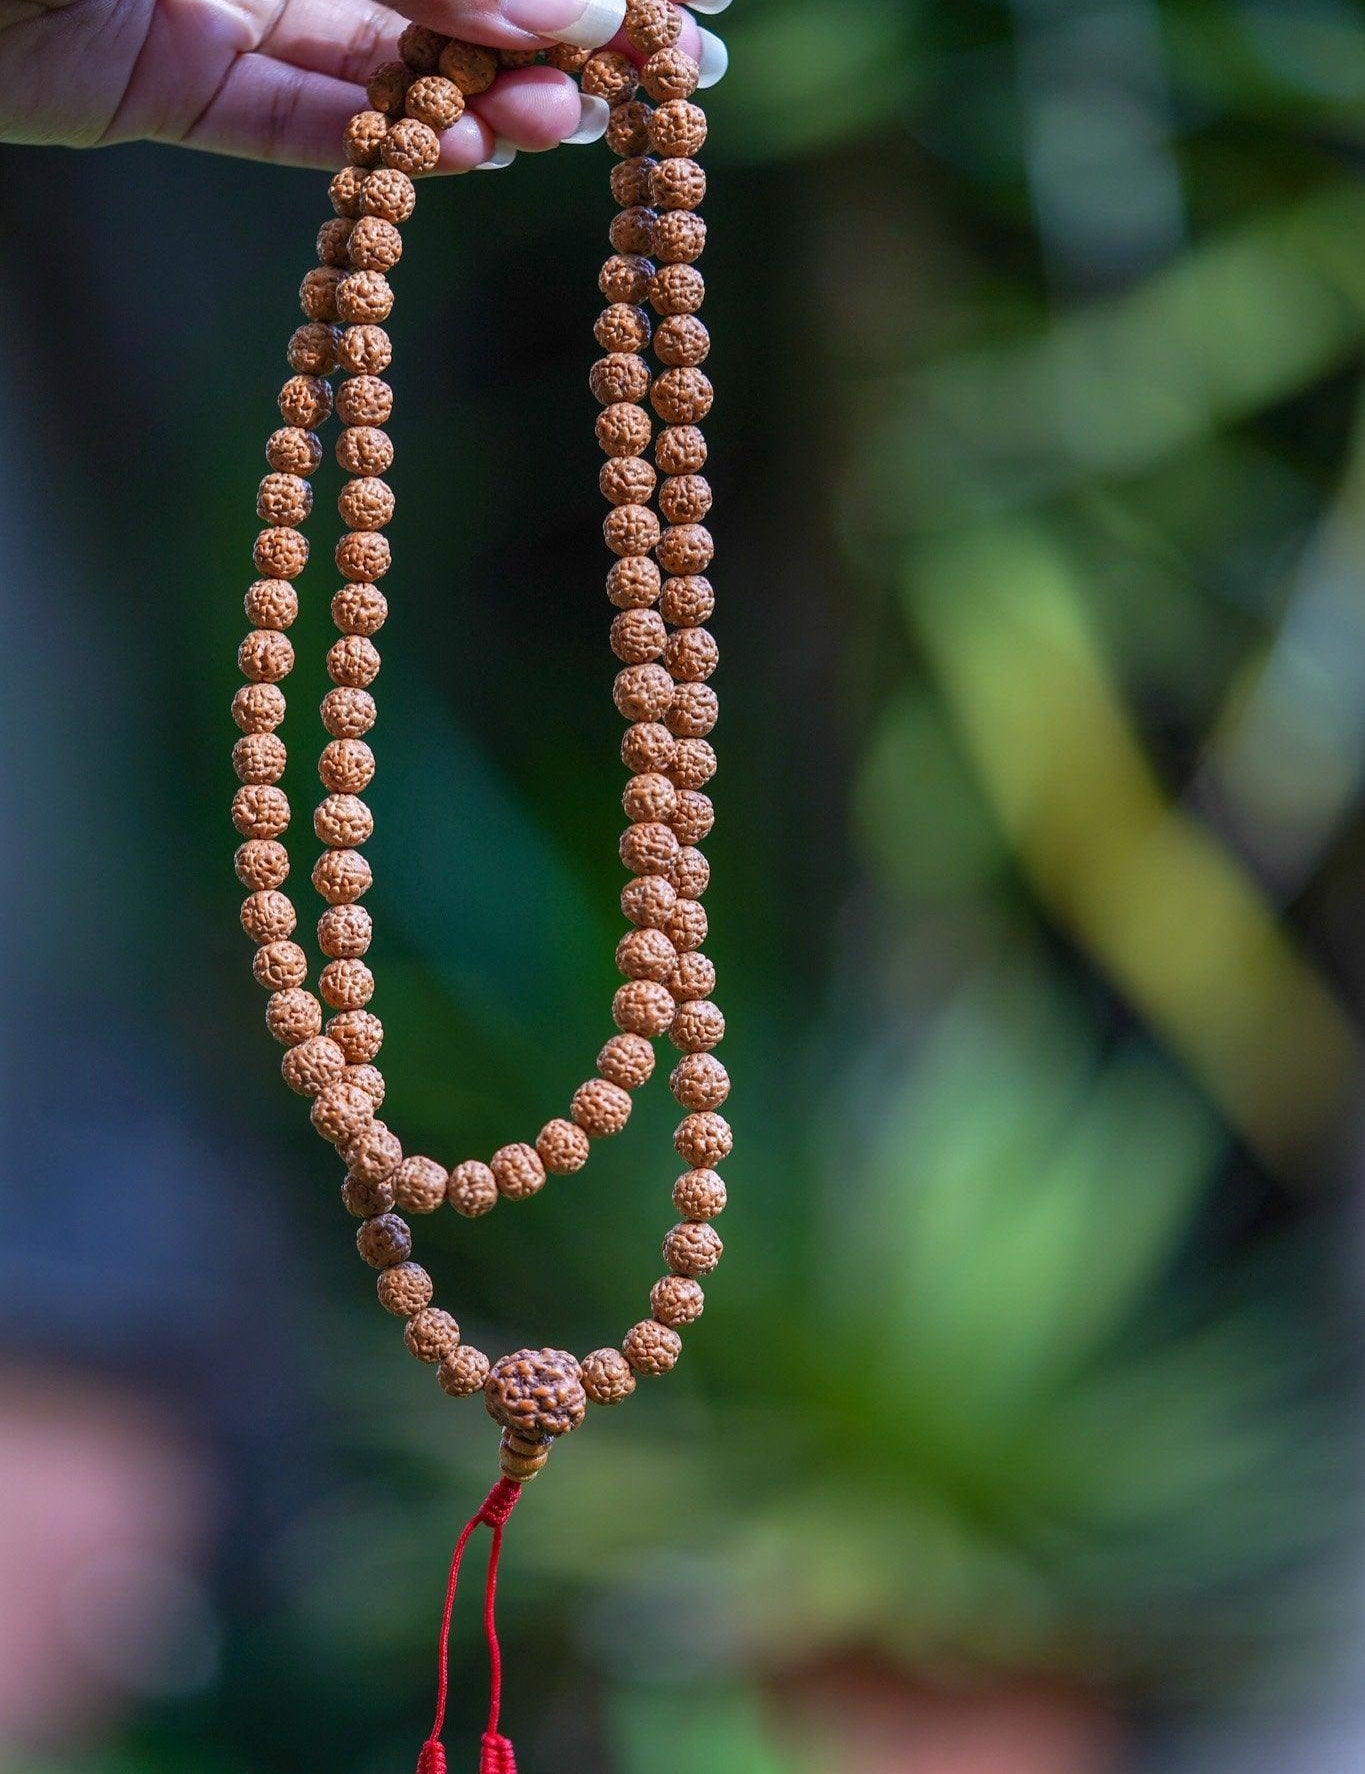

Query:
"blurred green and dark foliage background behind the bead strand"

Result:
[[0, 0, 1365, 1774]]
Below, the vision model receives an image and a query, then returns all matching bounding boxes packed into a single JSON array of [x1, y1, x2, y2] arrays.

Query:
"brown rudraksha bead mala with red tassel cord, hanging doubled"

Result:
[[233, 10, 731, 1774]]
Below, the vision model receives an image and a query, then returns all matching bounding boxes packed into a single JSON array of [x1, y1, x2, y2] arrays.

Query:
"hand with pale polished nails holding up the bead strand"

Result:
[[0, 0, 730, 172]]
